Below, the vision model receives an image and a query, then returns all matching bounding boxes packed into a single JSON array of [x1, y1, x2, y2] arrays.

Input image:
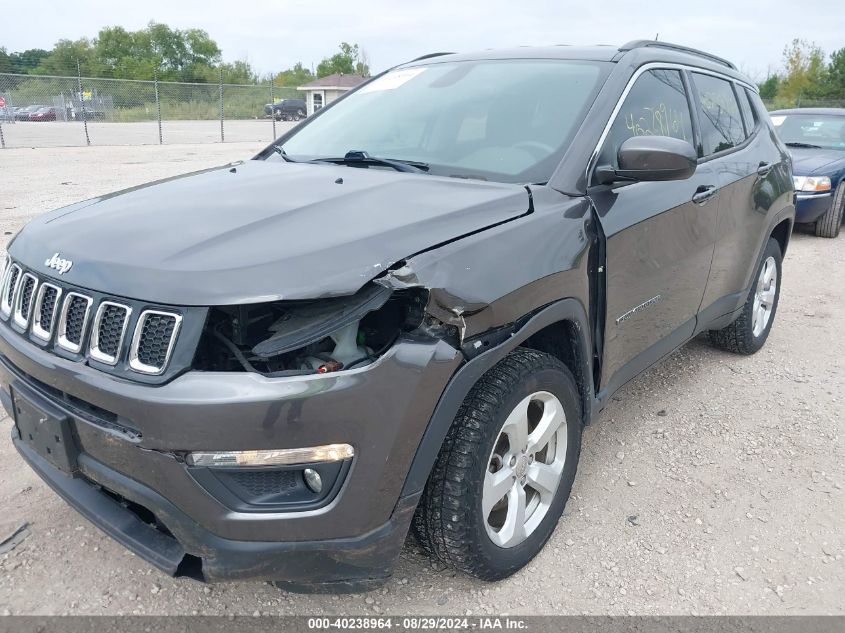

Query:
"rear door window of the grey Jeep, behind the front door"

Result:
[[692, 73, 745, 156]]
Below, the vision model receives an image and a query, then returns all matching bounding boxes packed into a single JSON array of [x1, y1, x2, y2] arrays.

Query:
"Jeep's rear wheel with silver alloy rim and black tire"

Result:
[[708, 237, 783, 354]]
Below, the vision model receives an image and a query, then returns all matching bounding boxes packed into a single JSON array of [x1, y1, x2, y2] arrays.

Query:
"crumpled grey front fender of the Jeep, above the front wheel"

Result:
[[374, 187, 594, 345]]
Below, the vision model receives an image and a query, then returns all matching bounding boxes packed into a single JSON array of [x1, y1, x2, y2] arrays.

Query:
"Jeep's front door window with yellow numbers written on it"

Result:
[[597, 69, 694, 173]]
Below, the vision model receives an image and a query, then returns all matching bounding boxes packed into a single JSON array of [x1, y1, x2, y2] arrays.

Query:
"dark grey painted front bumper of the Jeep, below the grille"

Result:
[[0, 325, 461, 590]]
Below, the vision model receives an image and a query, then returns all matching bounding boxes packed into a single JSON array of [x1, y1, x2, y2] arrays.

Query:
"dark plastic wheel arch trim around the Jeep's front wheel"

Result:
[[402, 299, 594, 497]]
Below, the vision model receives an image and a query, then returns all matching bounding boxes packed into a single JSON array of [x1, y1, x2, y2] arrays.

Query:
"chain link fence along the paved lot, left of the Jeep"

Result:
[[0, 73, 302, 148]]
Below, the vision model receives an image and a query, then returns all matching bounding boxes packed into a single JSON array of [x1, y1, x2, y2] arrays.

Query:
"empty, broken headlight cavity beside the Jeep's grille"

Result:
[[195, 284, 428, 377]]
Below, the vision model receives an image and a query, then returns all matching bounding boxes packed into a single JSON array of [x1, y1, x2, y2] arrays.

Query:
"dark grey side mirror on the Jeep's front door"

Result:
[[596, 136, 698, 184]]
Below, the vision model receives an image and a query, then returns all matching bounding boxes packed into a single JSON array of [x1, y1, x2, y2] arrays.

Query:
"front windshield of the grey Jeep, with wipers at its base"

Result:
[[271, 59, 610, 182]]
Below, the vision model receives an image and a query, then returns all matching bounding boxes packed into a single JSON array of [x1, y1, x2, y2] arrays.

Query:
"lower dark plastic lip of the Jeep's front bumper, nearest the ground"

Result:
[[12, 429, 419, 592]]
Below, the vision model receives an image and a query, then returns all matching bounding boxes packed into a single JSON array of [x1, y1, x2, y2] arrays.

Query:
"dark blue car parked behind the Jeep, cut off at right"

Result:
[[769, 108, 845, 237]]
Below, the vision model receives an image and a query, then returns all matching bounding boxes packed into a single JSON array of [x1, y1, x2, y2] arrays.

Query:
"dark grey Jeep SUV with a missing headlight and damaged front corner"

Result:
[[0, 41, 795, 591]]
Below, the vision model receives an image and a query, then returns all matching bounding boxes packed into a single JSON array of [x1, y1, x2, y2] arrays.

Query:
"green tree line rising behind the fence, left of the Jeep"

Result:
[[0, 22, 370, 88]]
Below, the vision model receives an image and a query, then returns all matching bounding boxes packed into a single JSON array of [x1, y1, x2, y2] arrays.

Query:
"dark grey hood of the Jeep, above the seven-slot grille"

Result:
[[9, 161, 529, 305]]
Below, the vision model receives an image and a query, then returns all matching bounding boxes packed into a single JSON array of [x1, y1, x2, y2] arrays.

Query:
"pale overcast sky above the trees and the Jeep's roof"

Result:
[[6, 0, 845, 78]]
